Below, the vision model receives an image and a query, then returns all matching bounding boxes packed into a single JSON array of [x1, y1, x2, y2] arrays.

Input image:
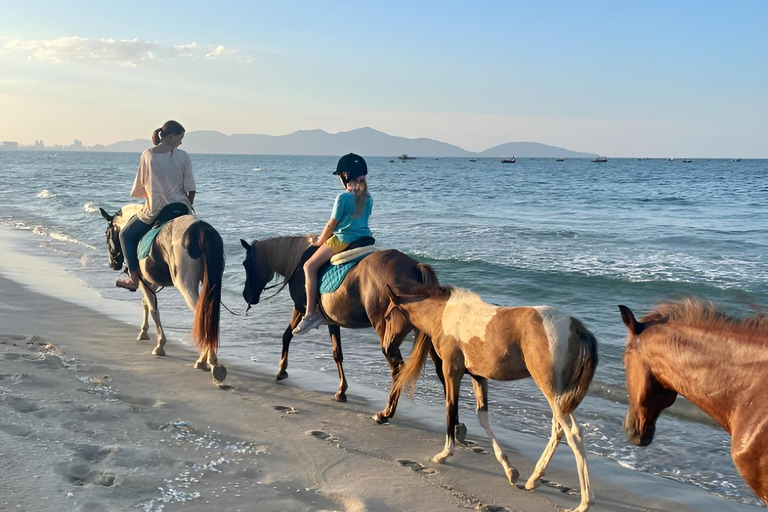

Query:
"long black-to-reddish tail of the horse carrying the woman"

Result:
[[184, 221, 224, 353]]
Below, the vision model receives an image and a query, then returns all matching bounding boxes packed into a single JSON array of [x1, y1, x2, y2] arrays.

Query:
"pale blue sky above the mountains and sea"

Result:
[[0, 0, 768, 158]]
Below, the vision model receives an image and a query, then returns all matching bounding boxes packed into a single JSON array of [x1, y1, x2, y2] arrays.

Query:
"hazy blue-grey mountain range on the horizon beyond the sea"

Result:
[[100, 128, 596, 158]]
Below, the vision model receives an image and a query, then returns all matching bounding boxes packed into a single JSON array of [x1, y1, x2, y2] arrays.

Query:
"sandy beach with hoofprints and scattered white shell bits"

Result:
[[0, 227, 759, 512]]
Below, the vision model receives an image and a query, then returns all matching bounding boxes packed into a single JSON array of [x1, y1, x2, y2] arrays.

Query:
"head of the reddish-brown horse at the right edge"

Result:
[[619, 306, 677, 446]]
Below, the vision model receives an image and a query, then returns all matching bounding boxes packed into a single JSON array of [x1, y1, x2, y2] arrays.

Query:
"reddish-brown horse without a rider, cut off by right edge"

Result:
[[619, 299, 768, 505]]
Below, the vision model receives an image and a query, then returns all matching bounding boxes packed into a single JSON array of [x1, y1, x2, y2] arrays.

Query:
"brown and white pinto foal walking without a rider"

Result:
[[384, 287, 597, 512]]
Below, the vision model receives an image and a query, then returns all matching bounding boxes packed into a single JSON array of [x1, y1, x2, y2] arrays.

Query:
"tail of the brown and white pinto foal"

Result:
[[556, 318, 597, 414]]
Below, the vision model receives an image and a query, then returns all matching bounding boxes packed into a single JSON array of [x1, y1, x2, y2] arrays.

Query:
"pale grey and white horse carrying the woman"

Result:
[[99, 204, 227, 382]]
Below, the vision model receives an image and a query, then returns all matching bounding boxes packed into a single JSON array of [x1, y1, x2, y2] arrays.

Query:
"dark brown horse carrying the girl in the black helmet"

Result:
[[240, 236, 442, 423]]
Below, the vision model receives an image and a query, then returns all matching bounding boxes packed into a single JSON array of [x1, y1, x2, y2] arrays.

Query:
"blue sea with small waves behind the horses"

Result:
[[0, 152, 768, 504]]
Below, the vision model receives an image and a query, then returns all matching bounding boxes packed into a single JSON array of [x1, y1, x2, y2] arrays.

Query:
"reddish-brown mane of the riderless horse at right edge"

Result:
[[640, 297, 768, 334]]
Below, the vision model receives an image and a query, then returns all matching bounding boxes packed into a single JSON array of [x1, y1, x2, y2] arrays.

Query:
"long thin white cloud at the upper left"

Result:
[[0, 36, 248, 67]]
